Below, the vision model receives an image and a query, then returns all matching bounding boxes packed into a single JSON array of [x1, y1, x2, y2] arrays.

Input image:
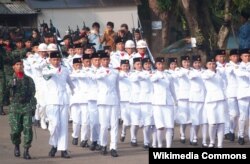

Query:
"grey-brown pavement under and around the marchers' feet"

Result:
[[0, 107, 250, 164]]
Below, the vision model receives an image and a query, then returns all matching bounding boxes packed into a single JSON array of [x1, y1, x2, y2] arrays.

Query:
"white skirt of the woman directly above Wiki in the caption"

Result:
[[153, 105, 174, 129]]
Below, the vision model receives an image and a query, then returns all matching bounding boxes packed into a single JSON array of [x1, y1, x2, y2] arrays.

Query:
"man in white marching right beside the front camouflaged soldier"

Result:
[[42, 51, 74, 158]]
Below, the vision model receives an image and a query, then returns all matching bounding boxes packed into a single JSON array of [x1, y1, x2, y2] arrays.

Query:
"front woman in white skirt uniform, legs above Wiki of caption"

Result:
[[151, 57, 176, 148]]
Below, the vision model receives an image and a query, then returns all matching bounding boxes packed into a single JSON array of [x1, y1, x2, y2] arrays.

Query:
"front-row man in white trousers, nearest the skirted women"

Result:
[[95, 53, 120, 157]]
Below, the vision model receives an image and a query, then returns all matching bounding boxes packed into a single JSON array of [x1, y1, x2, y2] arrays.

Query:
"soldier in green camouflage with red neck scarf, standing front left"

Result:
[[7, 58, 36, 159]]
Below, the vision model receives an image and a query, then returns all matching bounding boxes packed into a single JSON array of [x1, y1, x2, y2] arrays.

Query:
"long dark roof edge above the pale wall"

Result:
[[26, 0, 140, 9]]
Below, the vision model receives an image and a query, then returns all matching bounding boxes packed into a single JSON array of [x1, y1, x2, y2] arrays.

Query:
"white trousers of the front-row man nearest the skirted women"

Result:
[[98, 105, 119, 150]]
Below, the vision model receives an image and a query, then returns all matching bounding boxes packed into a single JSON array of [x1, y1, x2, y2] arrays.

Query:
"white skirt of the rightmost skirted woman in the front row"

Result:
[[204, 100, 226, 124]]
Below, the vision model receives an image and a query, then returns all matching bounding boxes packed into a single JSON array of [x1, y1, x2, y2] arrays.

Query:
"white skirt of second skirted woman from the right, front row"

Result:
[[189, 102, 207, 125]]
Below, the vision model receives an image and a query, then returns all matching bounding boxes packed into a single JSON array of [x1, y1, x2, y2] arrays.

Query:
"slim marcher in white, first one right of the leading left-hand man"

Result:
[[70, 58, 89, 147]]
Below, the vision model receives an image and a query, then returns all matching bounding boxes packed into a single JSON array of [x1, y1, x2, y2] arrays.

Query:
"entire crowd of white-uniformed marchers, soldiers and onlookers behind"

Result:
[[0, 19, 250, 159]]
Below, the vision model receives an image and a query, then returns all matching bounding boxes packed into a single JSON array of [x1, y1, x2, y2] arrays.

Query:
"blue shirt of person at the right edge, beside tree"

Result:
[[239, 21, 250, 49]]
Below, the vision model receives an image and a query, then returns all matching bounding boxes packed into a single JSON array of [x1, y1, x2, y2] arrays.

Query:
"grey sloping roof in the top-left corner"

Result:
[[0, 0, 37, 15]]
